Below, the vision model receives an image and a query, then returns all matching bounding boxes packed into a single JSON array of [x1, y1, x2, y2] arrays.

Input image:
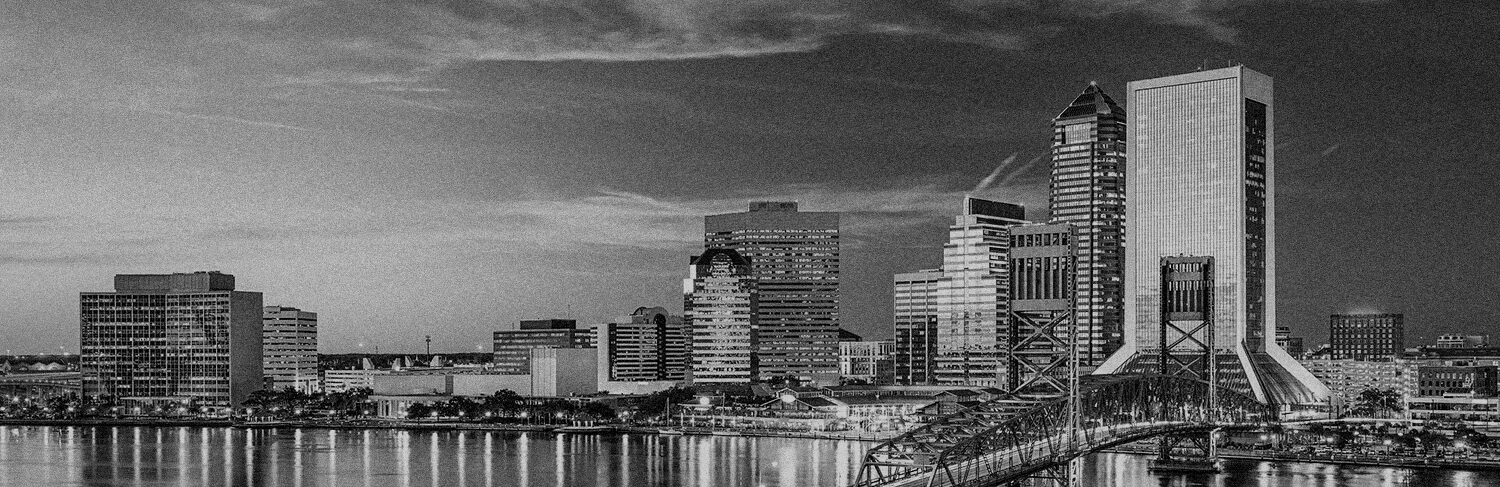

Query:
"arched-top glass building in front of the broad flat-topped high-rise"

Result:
[[683, 249, 762, 382]]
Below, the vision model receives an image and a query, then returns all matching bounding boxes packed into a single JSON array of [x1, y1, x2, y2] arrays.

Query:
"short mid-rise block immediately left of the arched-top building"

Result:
[[596, 307, 689, 381]]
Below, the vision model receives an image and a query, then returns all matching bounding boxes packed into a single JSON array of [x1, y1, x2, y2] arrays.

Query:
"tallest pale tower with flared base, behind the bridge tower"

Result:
[[1098, 66, 1328, 405]]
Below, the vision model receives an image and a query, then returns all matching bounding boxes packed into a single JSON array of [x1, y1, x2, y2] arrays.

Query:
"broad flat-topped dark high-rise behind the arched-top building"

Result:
[[704, 201, 839, 385]]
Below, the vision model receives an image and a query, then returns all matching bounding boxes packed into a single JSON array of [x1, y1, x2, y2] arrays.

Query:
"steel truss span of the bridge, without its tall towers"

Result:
[[855, 375, 1277, 487]]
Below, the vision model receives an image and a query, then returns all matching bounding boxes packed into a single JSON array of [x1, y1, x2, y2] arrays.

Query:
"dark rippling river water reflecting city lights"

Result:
[[0, 426, 1500, 487]]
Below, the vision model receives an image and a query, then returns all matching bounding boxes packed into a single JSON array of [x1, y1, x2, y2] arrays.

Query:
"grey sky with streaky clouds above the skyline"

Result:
[[0, 0, 1500, 354]]
